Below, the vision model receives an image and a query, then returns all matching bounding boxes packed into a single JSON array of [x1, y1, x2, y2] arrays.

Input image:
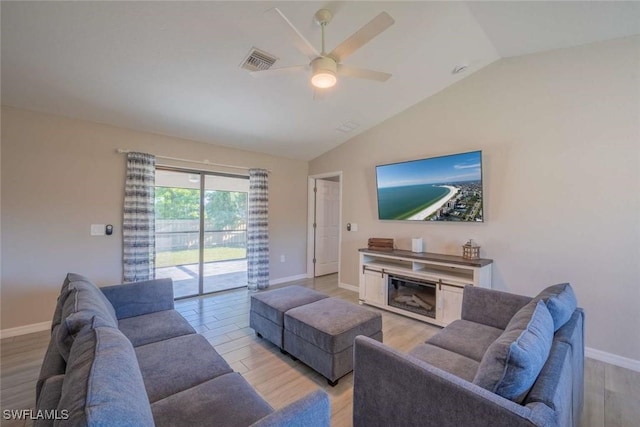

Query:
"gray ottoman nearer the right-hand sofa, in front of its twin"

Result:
[[284, 298, 382, 386]]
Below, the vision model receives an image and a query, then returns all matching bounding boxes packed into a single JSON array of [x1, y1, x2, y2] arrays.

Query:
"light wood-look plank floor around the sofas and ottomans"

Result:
[[0, 275, 640, 427]]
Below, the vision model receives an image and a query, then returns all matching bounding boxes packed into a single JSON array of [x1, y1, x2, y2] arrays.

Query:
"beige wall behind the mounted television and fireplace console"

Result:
[[309, 37, 640, 361]]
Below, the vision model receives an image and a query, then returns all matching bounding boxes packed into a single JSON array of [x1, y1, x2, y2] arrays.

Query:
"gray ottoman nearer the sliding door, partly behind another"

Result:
[[249, 285, 329, 349]]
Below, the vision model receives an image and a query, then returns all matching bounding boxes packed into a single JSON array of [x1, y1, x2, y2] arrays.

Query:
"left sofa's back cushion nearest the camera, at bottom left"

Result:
[[58, 324, 153, 426]]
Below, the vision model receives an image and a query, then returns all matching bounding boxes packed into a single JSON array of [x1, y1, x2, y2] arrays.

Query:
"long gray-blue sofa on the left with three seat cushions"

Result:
[[35, 273, 330, 427]]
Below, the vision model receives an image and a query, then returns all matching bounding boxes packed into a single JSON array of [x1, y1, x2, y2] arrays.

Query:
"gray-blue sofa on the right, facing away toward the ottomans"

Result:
[[353, 284, 584, 427]]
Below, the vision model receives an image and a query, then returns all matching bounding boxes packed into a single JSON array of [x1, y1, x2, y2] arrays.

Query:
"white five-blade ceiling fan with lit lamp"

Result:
[[251, 8, 395, 89]]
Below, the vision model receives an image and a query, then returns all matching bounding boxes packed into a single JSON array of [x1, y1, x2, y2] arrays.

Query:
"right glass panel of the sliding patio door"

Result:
[[202, 175, 249, 293]]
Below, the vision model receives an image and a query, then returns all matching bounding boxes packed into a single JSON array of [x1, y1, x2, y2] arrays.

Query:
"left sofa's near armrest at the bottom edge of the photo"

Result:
[[251, 390, 331, 427]]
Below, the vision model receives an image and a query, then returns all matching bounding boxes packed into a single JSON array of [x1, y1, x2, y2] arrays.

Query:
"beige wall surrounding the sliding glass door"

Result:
[[1, 108, 308, 329]]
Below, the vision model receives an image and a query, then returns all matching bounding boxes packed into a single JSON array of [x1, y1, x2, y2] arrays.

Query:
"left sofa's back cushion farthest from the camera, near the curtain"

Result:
[[54, 280, 118, 360]]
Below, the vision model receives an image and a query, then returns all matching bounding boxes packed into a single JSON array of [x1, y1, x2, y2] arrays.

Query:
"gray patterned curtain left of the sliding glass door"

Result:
[[122, 153, 156, 282]]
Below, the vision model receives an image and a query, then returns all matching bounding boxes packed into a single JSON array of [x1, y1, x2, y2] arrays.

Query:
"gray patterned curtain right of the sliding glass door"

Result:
[[247, 169, 269, 291]]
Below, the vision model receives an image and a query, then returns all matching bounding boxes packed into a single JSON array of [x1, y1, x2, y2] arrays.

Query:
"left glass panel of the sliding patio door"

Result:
[[155, 169, 201, 298]]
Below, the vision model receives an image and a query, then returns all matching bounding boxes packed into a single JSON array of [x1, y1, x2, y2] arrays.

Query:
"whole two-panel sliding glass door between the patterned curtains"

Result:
[[156, 168, 249, 298]]
